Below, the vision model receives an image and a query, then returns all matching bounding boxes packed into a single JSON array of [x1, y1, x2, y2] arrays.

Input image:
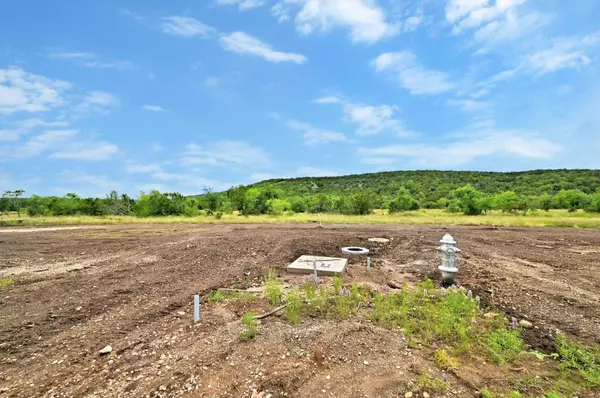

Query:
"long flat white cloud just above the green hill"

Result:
[[358, 129, 562, 167]]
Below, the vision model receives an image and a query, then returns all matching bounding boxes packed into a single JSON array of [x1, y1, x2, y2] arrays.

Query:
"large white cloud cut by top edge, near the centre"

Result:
[[271, 0, 400, 43]]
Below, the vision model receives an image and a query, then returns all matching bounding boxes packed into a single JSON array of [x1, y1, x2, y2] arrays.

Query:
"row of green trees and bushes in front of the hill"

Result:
[[0, 183, 600, 218]]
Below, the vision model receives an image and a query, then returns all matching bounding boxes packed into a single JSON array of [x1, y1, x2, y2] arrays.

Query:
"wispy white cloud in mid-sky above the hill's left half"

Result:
[[314, 96, 414, 137]]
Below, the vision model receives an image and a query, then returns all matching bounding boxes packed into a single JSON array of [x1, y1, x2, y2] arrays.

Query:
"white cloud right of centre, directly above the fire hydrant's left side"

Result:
[[371, 51, 456, 94]]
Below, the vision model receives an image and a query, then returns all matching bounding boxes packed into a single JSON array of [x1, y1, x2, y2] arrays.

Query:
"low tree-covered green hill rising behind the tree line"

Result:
[[251, 169, 600, 202]]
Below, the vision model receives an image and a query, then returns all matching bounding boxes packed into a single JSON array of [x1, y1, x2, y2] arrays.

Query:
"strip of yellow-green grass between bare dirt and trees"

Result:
[[0, 210, 600, 228]]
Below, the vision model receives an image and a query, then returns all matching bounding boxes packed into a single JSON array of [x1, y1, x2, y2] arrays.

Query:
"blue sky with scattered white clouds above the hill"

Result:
[[0, 0, 600, 196]]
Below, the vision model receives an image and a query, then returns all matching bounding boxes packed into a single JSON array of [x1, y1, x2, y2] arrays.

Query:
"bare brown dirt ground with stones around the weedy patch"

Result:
[[0, 225, 600, 397]]
